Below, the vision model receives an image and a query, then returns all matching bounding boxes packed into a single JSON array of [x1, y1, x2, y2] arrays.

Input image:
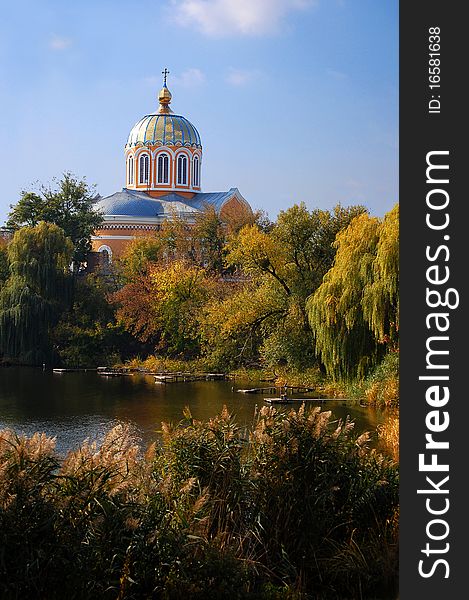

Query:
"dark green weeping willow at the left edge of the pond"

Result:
[[0, 222, 73, 364]]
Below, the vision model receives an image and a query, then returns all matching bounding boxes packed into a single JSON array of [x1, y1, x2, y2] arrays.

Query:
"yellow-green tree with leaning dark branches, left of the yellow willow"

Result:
[[202, 203, 364, 369]]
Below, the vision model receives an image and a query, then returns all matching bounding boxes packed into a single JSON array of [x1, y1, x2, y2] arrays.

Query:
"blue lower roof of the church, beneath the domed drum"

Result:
[[95, 188, 244, 218]]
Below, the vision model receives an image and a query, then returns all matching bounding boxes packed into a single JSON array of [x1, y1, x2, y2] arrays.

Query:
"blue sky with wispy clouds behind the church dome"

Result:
[[0, 0, 398, 225]]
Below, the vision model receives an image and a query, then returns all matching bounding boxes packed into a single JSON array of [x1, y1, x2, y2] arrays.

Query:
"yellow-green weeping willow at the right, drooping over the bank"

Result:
[[307, 206, 399, 379]]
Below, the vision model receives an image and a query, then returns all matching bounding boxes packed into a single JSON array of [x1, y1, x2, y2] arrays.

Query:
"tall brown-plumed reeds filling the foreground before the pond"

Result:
[[0, 406, 398, 600]]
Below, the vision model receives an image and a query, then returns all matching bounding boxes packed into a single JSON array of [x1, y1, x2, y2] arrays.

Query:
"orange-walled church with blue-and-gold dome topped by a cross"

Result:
[[92, 69, 252, 262]]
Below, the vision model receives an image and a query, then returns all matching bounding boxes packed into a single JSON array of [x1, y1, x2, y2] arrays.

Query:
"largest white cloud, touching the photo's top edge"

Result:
[[171, 0, 317, 37]]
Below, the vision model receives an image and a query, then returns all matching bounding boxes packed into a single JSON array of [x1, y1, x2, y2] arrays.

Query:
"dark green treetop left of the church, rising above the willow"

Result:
[[6, 173, 103, 266]]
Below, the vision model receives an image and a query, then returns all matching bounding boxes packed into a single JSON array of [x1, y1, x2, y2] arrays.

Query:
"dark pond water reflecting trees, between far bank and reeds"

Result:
[[0, 368, 383, 454]]
